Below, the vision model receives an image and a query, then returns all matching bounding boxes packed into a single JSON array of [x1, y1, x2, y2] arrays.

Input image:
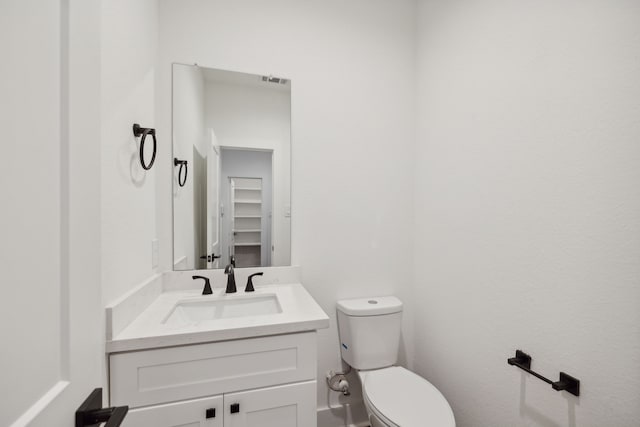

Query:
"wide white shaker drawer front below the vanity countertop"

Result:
[[114, 332, 317, 408]]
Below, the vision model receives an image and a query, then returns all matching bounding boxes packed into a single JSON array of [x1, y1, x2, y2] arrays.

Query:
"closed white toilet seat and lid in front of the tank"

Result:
[[360, 366, 455, 427]]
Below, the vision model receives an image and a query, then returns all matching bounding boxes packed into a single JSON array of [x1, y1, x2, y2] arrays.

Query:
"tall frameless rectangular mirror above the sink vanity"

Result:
[[172, 64, 291, 270]]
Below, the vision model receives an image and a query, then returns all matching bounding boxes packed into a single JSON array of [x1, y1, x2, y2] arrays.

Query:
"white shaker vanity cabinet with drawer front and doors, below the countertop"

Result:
[[109, 332, 317, 427]]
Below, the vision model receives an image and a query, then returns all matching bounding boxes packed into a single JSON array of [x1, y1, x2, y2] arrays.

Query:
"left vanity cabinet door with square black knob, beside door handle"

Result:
[[122, 396, 224, 427]]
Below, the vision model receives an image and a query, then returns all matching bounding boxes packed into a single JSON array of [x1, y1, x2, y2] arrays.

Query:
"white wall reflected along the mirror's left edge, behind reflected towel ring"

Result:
[[172, 65, 207, 269]]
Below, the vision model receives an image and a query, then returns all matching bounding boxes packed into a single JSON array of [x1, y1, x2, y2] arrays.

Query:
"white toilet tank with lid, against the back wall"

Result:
[[337, 296, 402, 369]]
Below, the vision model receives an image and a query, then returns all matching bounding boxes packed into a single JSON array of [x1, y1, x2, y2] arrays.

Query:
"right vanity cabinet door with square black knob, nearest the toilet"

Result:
[[224, 381, 317, 427]]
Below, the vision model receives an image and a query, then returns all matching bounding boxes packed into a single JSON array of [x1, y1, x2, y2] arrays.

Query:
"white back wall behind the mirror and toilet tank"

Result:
[[157, 0, 414, 422]]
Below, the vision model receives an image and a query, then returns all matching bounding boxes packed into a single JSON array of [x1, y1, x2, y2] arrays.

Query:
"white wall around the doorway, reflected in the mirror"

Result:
[[206, 81, 291, 266]]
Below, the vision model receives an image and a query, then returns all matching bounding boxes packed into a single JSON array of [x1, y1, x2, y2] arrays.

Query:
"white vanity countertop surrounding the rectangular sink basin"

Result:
[[106, 283, 329, 353]]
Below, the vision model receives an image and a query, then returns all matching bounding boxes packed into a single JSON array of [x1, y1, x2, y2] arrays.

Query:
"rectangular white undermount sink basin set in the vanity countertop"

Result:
[[162, 294, 282, 325]]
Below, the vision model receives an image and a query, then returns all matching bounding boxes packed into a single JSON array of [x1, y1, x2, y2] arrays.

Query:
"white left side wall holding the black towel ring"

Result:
[[101, 0, 160, 303]]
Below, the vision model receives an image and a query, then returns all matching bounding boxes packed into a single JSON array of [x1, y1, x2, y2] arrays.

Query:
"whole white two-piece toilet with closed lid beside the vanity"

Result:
[[337, 296, 456, 427]]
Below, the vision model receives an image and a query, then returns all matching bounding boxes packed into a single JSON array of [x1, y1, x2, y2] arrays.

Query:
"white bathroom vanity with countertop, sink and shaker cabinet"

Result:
[[107, 273, 329, 427]]
